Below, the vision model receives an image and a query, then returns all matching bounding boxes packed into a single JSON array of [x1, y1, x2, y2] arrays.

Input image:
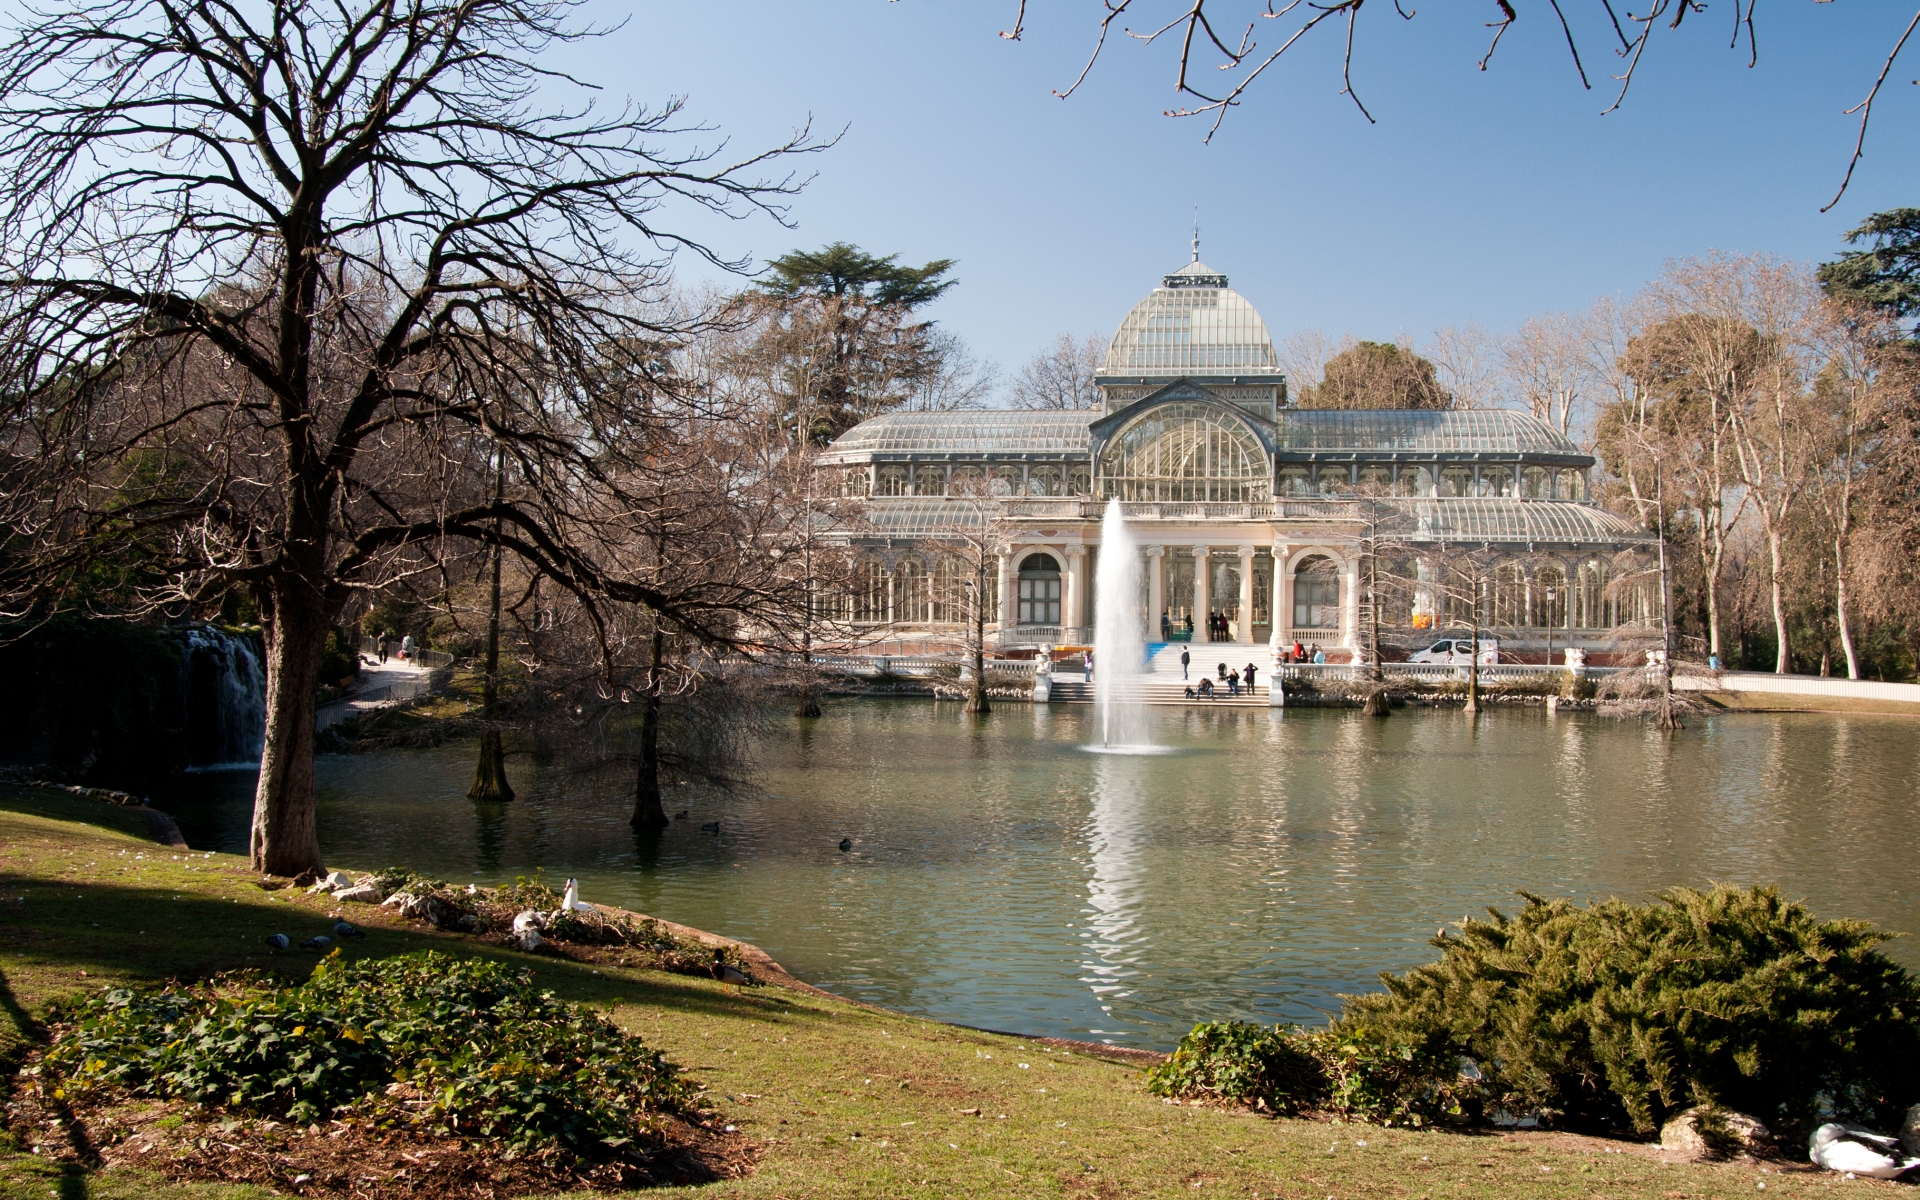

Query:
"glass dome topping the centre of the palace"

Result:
[[1100, 261, 1279, 378]]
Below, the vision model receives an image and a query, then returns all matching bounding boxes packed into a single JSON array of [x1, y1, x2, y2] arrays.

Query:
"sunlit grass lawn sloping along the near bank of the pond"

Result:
[[0, 789, 1897, 1200]]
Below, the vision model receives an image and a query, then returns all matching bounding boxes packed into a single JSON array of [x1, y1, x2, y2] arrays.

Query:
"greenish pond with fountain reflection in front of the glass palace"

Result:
[[154, 701, 1920, 1048]]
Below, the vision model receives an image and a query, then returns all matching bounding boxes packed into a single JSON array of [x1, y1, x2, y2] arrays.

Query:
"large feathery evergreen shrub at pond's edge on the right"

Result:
[[1332, 885, 1920, 1140]]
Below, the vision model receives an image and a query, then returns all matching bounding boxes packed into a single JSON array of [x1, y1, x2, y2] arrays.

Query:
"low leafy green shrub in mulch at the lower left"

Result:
[[35, 952, 691, 1156]]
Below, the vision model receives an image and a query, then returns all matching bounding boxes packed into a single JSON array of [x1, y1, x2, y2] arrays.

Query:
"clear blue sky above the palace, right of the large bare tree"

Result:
[[591, 0, 1920, 369]]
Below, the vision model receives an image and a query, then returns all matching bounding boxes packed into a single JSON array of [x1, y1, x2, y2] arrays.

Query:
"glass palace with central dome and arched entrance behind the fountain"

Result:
[[820, 259, 1659, 660]]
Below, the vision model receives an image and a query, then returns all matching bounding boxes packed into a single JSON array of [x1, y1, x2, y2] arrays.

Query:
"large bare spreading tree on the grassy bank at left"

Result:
[[0, 0, 816, 874]]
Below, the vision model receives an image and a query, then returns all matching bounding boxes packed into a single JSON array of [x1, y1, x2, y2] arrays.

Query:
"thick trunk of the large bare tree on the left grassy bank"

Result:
[[248, 595, 328, 877]]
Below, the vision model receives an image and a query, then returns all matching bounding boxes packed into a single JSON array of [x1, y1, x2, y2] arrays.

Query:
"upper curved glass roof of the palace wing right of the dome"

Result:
[[1275, 409, 1582, 455]]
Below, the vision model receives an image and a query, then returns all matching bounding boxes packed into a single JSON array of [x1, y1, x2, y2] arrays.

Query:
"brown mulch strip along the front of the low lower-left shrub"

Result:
[[8, 1091, 758, 1200]]
